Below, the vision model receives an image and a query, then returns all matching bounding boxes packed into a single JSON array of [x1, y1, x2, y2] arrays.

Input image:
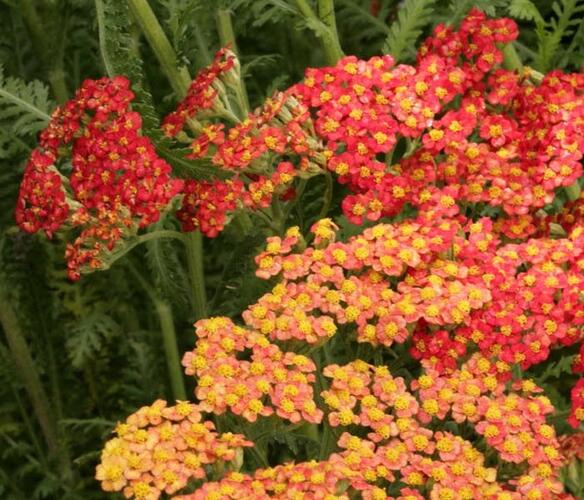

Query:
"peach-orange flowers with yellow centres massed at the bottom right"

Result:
[[322, 354, 563, 499]]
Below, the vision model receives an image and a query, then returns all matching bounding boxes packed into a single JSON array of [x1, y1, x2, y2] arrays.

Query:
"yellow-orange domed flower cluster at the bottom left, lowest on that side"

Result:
[[96, 400, 252, 500]]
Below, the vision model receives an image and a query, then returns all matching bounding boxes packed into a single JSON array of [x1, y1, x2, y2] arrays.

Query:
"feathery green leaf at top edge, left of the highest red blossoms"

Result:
[[383, 0, 436, 62]]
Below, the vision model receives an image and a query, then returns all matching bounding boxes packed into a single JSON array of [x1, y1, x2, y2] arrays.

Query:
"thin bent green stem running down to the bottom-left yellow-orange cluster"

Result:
[[127, 261, 187, 401]]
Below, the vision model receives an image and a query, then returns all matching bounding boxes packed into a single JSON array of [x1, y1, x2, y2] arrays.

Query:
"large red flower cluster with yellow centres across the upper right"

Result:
[[163, 9, 584, 237]]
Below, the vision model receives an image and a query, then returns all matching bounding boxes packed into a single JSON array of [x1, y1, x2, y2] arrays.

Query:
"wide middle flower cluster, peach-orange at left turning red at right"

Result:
[[252, 217, 584, 420]]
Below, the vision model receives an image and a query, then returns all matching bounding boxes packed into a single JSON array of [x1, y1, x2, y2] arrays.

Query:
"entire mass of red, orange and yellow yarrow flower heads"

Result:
[[16, 4, 584, 500]]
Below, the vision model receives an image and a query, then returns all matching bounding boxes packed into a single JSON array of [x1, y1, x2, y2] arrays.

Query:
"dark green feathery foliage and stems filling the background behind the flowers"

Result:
[[0, 0, 584, 499]]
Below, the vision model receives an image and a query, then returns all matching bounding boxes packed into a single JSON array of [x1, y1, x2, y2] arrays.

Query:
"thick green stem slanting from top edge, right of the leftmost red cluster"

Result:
[[128, 0, 191, 98]]
